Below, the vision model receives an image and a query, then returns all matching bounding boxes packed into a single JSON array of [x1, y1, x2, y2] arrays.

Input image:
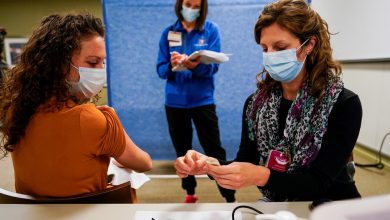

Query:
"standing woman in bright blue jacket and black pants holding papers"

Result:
[[156, 0, 235, 203]]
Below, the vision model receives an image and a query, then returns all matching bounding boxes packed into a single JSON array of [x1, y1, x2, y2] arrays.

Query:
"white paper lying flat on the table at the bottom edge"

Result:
[[134, 210, 242, 220]]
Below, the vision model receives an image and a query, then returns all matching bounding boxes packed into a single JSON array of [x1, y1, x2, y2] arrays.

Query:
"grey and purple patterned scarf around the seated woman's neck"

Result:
[[246, 76, 344, 201]]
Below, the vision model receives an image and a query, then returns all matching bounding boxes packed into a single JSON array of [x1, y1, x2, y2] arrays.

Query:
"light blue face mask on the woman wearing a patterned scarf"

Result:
[[263, 39, 309, 82]]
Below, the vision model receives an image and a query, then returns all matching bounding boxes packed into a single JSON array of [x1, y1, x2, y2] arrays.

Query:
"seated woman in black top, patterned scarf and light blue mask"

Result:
[[175, 0, 362, 201]]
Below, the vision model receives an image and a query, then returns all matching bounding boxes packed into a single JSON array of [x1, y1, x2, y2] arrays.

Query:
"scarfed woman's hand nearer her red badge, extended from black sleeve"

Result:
[[205, 162, 270, 189]]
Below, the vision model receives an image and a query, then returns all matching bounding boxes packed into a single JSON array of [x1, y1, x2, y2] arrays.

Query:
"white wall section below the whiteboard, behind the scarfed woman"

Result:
[[343, 62, 390, 155]]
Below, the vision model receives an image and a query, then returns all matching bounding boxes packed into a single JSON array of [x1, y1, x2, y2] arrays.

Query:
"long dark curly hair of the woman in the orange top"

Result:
[[0, 13, 104, 156]]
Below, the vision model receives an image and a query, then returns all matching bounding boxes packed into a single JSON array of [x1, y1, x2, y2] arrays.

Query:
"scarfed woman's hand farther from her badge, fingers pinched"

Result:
[[175, 150, 212, 178]]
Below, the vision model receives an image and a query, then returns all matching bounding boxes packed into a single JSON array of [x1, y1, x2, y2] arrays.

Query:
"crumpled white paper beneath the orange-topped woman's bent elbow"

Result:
[[107, 160, 150, 189]]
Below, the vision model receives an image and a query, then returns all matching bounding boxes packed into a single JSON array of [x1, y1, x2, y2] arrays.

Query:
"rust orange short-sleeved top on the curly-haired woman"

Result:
[[11, 104, 126, 197]]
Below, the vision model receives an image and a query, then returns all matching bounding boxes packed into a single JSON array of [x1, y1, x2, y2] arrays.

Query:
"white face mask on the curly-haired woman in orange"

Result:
[[67, 64, 107, 98]]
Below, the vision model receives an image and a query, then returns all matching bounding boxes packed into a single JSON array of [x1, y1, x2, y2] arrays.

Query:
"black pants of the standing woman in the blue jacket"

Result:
[[165, 104, 235, 202]]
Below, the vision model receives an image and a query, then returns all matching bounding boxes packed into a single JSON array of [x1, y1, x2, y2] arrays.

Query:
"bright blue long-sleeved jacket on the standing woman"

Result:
[[156, 21, 221, 108]]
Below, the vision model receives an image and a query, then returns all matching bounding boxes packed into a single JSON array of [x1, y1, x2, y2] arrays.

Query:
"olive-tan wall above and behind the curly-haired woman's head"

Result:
[[0, 0, 107, 104]]
